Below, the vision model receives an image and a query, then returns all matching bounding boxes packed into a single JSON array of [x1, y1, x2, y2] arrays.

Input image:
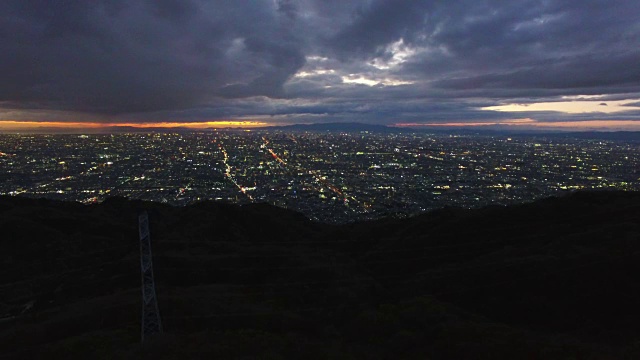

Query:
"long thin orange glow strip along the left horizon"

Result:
[[0, 120, 273, 130]]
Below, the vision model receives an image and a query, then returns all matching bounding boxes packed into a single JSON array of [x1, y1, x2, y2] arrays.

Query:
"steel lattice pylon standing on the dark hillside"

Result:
[[138, 211, 162, 342]]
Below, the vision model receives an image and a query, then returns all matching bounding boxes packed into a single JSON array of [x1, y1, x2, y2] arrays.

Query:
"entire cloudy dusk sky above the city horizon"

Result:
[[0, 0, 640, 130]]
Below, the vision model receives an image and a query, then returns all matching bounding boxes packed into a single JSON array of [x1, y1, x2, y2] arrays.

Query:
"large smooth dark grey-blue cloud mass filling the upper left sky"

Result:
[[0, 0, 304, 113]]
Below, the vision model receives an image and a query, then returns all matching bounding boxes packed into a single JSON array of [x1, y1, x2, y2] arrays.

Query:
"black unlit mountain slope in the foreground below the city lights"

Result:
[[0, 192, 640, 359]]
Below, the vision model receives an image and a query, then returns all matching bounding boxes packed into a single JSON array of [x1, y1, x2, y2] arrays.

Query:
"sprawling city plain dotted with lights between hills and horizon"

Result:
[[0, 131, 640, 222]]
